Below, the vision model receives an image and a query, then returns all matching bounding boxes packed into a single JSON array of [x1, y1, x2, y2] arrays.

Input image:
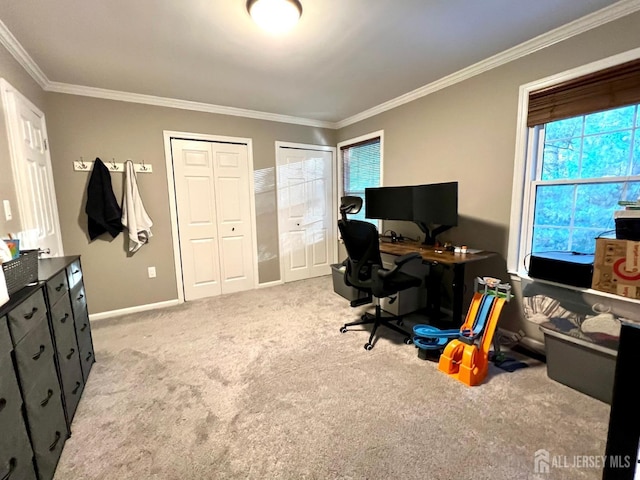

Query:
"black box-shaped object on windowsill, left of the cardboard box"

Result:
[[529, 252, 594, 288]]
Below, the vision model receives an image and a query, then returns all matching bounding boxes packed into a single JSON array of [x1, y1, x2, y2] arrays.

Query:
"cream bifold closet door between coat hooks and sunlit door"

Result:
[[171, 139, 254, 300]]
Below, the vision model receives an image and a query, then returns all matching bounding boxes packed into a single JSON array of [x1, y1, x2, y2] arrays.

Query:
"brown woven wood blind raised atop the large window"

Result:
[[527, 59, 640, 127]]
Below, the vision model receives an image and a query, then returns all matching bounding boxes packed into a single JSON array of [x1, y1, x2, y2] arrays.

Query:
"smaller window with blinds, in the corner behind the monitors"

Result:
[[338, 132, 382, 225]]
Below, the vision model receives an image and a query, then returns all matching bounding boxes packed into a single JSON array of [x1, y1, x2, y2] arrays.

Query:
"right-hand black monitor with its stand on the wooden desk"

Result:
[[412, 182, 458, 245]]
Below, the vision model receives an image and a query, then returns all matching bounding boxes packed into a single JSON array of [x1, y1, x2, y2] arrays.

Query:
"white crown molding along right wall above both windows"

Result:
[[336, 0, 640, 128]]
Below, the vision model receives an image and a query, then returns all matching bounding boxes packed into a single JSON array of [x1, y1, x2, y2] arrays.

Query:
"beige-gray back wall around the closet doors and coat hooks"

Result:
[[46, 93, 336, 313]]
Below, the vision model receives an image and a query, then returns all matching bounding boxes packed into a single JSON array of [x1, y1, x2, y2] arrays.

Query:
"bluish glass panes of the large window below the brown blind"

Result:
[[531, 105, 640, 253]]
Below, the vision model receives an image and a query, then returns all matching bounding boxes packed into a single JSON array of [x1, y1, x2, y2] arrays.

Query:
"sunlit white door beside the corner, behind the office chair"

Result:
[[277, 146, 336, 282]]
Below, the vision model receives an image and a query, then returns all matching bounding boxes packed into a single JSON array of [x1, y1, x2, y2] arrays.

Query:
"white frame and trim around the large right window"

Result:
[[507, 48, 640, 302]]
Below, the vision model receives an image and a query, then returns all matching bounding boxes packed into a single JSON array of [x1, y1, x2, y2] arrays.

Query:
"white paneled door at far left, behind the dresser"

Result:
[[0, 80, 64, 257]]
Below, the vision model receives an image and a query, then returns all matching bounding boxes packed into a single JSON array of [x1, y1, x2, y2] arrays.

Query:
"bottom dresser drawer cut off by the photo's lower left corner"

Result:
[[0, 426, 36, 480]]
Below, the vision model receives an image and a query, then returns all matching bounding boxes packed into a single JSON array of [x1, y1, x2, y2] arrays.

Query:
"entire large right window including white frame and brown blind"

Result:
[[508, 53, 640, 271]]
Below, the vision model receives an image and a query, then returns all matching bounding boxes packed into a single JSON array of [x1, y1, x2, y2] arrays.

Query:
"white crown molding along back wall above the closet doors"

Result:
[[46, 82, 336, 129]]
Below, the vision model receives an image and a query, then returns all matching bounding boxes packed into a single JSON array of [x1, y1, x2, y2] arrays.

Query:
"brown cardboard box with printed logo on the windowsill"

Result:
[[591, 238, 640, 299]]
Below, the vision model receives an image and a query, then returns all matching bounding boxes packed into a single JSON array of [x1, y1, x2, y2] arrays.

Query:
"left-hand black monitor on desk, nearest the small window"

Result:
[[364, 187, 413, 221]]
